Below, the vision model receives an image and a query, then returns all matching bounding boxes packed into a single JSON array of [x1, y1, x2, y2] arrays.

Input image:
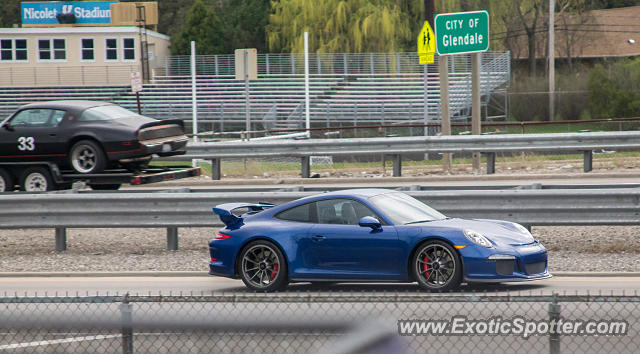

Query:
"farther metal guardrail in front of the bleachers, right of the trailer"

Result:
[[171, 131, 640, 179]]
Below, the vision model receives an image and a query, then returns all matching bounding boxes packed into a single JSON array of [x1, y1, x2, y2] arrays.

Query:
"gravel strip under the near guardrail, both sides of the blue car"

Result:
[[0, 226, 640, 274]]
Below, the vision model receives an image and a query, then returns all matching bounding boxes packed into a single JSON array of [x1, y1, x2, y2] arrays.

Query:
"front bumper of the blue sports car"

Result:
[[460, 242, 551, 282]]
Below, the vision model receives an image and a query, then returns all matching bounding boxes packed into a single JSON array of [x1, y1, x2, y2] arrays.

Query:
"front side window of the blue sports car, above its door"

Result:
[[316, 199, 379, 225]]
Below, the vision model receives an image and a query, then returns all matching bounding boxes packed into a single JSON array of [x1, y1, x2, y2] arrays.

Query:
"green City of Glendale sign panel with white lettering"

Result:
[[435, 11, 489, 55]]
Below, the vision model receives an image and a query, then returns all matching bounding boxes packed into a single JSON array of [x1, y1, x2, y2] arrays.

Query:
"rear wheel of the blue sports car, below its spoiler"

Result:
[[238, 241, 287, 292]]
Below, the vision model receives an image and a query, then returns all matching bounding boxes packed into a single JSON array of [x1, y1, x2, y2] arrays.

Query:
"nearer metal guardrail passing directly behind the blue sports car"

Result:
[[0, 188, 640, 251]]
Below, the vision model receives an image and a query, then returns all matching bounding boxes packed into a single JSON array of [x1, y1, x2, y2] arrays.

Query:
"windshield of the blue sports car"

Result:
[[369, 192, 447, 225]]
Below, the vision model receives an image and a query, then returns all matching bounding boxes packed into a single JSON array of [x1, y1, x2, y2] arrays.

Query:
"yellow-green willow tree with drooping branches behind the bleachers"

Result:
[[267, 0, 423, 52]]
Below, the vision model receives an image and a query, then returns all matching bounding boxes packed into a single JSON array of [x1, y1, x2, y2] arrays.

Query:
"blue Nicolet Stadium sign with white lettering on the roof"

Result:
[[20, 1, 117, 27]]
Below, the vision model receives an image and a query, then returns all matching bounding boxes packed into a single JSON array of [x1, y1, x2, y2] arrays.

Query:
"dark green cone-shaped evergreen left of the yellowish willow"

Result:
[[171, 0, 226, 55]]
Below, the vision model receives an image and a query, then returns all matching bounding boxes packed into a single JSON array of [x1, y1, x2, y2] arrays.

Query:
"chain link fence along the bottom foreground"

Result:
[[0, 293, 640, 353]]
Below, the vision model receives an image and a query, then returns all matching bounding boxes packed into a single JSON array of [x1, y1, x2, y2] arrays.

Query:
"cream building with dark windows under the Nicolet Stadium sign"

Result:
[[0, 3, 170, 87]]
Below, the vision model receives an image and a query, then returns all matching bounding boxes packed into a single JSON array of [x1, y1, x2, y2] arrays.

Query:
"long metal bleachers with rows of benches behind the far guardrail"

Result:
[[0, 52, 510, 132]]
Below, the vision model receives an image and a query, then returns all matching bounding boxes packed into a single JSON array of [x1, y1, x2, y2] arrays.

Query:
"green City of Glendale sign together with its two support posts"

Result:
[[435, 11, 489, 173]]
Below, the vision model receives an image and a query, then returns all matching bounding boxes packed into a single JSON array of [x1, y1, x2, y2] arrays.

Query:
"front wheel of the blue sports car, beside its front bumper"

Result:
[[411, 240, 462, 291]]
